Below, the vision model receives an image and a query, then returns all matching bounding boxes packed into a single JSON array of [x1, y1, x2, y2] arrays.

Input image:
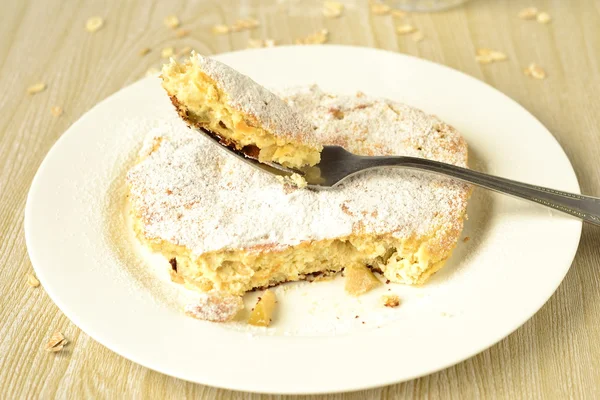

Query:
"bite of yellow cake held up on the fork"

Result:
[[161, 54, 322, 168]]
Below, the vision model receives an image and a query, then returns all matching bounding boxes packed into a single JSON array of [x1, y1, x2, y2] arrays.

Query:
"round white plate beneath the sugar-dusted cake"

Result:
[[25, 46, 581, 393]]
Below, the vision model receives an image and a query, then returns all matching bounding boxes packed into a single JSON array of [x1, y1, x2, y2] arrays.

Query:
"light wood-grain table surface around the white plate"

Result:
[[0, 0, 600, 399]]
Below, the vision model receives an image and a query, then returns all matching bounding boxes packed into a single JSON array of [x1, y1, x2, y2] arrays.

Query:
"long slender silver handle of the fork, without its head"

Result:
[[361, 157, 600, 226]]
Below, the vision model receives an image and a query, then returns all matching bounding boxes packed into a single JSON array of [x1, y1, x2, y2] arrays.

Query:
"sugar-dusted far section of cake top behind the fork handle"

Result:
[[278, 85, 467, 167]]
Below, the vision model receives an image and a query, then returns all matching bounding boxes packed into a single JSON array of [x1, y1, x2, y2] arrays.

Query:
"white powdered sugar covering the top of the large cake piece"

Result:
[[128, 87, 468, 254]]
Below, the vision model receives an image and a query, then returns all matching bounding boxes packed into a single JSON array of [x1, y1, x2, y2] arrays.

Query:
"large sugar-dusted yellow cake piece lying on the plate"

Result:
[[127, 86, 470, 295]]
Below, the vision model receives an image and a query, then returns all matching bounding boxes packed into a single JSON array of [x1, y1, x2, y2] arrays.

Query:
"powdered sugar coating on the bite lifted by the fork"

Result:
[[192, 54, 319, 146]]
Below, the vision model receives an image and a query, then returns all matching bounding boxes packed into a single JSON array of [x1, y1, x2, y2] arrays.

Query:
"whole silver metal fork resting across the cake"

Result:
[[200, 129, 600, 226]]
